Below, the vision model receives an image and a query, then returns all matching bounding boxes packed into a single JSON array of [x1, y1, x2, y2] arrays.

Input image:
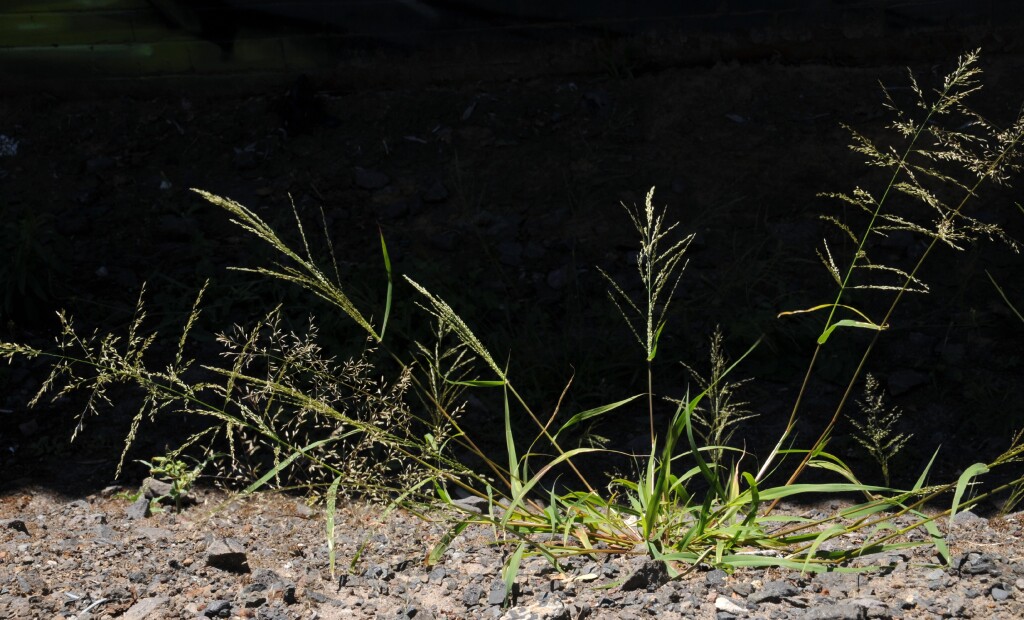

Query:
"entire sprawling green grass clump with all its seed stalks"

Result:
[[0, 49, 1024, 591]]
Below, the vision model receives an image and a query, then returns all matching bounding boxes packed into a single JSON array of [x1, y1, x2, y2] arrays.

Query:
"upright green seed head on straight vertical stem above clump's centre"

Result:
[[598, 188, 693, 452]]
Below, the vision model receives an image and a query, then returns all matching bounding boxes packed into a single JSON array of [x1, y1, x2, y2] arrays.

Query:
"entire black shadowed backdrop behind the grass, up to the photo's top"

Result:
[[0, 0, 1024, 498]]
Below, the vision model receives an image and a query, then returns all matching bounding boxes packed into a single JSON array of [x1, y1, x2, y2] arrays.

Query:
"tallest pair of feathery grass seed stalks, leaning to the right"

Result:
[[757, 51, 1024, 507]]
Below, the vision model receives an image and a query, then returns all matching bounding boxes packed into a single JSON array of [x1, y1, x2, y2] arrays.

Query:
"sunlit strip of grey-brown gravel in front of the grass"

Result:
[[0, 489, 1024, 620]]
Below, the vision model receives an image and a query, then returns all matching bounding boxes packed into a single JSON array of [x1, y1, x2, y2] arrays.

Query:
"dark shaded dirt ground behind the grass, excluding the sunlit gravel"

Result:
[[0, 40, 1024, 617]]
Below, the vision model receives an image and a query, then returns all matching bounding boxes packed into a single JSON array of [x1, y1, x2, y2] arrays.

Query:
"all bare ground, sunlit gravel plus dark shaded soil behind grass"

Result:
[[0, 38, 1024, 618]]
